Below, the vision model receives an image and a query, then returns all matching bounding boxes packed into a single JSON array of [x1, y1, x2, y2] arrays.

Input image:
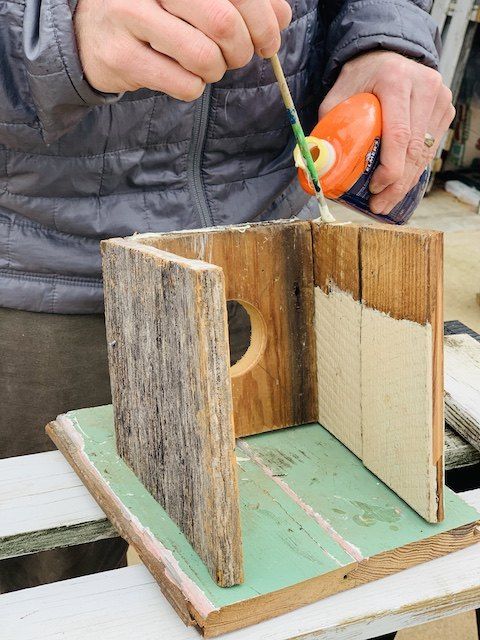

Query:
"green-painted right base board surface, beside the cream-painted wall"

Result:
[[248, 424, 479, 557]]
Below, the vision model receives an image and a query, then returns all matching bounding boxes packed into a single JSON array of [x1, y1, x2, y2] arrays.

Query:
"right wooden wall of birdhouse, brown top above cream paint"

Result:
[[313, 223, 443, 522]]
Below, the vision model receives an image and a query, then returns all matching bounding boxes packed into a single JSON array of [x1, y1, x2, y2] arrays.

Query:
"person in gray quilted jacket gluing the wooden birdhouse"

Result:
[[0, 0, 454, 591]]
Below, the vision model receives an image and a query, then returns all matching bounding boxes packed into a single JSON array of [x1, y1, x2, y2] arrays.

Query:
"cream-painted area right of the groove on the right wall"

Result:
[[362, 307, 437, 522]]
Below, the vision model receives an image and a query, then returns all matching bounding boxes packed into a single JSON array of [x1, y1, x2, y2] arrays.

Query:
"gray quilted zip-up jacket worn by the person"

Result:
[[0, 0, 438, 313]]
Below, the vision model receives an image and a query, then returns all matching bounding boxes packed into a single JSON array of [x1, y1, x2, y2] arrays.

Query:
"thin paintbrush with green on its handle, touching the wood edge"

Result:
[[270, 54, 335, 222]]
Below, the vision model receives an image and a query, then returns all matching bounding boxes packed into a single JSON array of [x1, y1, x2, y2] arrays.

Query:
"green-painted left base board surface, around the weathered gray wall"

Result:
[[67, 406, 352, 607]]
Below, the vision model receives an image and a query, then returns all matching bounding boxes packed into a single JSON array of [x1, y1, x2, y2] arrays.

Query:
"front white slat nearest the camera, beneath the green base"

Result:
[[0, 490, 480, 640]]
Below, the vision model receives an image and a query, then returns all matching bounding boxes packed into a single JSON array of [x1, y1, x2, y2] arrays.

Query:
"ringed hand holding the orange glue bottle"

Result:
[[320, 51, 455, 215]]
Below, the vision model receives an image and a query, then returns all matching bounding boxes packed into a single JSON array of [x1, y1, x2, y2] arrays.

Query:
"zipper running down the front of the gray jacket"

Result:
[[187, 84, 215, 227]]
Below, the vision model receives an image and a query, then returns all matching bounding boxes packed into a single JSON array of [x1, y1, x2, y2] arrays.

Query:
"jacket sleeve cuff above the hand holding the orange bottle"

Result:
[[324, 0, 441, 86]]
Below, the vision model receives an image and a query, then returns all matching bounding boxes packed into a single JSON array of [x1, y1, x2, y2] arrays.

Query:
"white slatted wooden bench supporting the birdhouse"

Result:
[[0, 436, 480, 640]]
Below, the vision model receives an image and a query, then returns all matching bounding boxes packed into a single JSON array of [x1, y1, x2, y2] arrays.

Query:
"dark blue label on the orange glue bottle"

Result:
[[339, 138, 430, 224]]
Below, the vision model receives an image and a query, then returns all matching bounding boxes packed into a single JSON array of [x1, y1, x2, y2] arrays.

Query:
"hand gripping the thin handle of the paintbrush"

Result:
[[74, 0, 292, 101]]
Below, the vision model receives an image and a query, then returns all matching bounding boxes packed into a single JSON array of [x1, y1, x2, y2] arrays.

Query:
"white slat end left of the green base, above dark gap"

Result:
[[0, 451, 116, 559]]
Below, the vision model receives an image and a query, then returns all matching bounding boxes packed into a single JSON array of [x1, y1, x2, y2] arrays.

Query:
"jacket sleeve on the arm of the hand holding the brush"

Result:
[[23, 0, 121, 144]]
